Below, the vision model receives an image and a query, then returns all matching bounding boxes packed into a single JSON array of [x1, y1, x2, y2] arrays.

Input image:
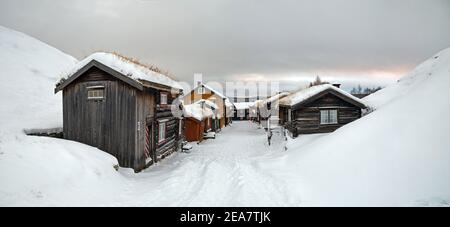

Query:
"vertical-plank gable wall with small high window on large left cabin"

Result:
[[63, 68, 139, 167]]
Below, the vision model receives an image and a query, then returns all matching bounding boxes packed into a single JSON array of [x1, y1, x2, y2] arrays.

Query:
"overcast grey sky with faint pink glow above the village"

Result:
[[0, 0, 450, 88]]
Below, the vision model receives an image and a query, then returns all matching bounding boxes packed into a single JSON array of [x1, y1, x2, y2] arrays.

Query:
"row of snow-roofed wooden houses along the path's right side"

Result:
[[239, 84, 367, 137]]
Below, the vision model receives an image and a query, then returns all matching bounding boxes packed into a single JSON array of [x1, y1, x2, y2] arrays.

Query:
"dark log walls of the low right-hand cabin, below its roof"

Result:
[[280, 94, 361, 136]]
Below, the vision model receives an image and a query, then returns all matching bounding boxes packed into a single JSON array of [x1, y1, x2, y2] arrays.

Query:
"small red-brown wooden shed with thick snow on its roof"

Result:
[[183, 102, 215, 142]]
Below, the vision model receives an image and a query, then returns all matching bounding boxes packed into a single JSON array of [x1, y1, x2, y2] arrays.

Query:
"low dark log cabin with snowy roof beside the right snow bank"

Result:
[[279, 84, 366, 137]]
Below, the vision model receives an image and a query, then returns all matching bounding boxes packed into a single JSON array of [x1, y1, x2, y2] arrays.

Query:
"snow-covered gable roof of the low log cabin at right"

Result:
[[279, 84, 365, 106]]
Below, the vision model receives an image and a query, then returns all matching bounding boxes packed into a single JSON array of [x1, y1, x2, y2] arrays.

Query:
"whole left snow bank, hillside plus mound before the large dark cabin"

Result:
[[0, 26, 124, 206]]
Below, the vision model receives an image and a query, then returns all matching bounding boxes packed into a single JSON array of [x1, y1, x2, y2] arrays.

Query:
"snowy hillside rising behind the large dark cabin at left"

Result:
[[0, 26, 76, 133]]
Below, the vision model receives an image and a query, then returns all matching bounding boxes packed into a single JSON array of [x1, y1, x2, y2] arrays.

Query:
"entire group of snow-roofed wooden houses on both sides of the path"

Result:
[[55, 53, 365, 171]]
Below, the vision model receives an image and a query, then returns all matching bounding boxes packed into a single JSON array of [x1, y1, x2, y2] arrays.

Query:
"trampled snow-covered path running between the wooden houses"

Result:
[[114, 122, 300, 206]]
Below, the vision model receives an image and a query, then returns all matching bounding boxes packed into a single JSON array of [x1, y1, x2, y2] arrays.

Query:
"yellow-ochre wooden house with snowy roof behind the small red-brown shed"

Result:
[[184, 83, 234, 128]]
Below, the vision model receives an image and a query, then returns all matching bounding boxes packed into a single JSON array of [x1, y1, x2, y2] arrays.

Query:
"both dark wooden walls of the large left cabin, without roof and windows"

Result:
[[63, 64, 182, 171]]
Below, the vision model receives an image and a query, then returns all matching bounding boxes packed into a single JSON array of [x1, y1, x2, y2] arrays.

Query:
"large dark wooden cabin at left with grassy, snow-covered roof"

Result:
[[55, 53, 182, 171]]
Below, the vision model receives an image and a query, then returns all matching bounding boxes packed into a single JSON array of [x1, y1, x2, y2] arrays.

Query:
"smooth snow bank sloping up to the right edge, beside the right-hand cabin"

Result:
[[278, 49, 450, 205]]
